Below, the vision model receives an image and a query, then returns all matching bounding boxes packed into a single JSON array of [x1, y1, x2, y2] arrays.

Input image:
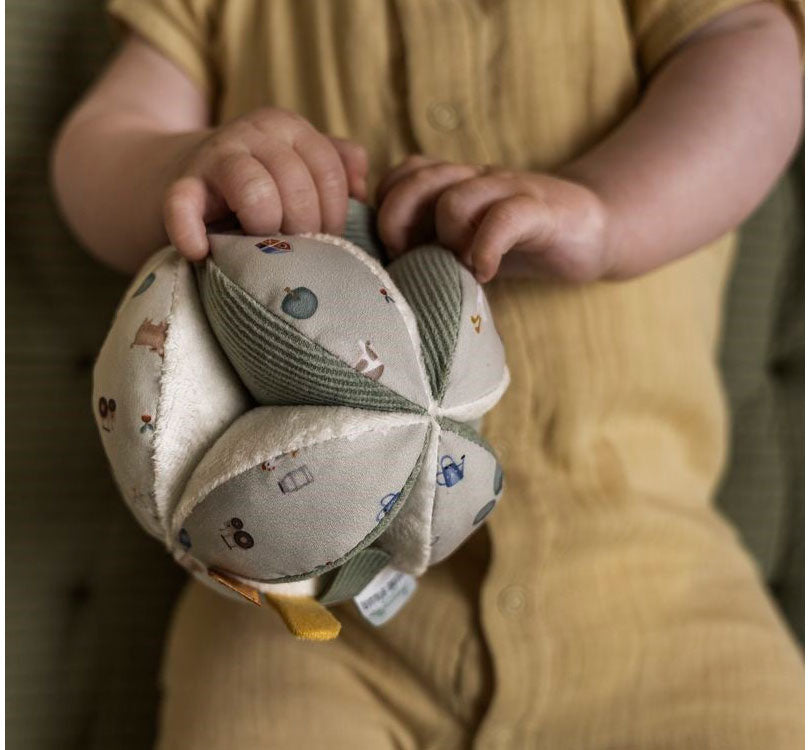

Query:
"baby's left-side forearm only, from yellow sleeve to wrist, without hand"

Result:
[[51, 37, 209, 272]]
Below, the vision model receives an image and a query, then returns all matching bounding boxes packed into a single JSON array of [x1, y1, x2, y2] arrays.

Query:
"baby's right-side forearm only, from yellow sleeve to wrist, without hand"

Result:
[[561, 4, 802, 278]]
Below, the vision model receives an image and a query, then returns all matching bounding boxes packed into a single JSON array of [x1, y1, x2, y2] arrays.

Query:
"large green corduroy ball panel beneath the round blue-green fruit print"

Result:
[[199, 260, 424, 414]]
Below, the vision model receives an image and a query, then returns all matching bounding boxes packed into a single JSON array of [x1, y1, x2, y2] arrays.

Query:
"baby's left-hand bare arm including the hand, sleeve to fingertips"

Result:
[[52, 36, 367, 271]]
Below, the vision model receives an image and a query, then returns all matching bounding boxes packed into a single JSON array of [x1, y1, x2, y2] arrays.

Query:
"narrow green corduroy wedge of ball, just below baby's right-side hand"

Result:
[[387, 245, 461, 400]]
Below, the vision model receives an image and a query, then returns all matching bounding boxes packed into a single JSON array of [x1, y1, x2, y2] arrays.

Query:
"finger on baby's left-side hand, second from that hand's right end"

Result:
[[295, 131, 349, 234]]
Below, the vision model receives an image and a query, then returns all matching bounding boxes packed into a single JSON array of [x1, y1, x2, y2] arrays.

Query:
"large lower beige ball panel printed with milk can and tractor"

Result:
[[175, 414, 429, 582]]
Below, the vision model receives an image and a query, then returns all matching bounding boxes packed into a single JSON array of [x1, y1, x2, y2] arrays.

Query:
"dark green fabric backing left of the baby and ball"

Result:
[[5, 0, 185, 750]]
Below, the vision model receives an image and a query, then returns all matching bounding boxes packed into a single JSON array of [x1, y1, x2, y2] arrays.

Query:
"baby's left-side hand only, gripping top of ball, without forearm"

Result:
[[163, 108, 368, 261]]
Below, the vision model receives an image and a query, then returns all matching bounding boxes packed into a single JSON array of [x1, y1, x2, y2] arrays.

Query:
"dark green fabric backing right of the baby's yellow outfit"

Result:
[[717, 148, 804, 642]]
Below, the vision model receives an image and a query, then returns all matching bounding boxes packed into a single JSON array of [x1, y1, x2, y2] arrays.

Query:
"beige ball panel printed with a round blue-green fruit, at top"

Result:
[[205, 235, 429, 408]]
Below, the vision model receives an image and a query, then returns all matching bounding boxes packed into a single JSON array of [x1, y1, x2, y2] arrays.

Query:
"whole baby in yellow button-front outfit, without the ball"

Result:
[[53, 0, 803, 750]]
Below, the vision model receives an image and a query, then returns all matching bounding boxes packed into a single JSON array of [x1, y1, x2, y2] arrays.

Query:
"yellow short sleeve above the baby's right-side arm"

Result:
[[626, 0, 804, 74]]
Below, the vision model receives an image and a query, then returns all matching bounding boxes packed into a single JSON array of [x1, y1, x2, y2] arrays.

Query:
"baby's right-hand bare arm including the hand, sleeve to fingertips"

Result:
[[379, 2, 802, 281]]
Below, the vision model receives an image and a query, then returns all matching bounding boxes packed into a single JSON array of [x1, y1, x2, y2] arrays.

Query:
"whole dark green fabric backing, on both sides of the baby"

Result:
[[5, 0, 804, 750]]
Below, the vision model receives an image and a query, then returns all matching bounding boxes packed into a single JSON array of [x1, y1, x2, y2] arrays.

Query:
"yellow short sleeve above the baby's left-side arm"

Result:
[[107, 0, 219, 98]]
